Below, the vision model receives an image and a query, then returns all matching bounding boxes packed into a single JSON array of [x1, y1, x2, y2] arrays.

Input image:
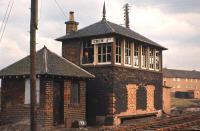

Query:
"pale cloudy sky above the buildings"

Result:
[[0, 0, 200, 70]]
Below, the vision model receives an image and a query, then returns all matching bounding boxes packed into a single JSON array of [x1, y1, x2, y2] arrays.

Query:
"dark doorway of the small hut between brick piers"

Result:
[[53, 81, 64, 126]]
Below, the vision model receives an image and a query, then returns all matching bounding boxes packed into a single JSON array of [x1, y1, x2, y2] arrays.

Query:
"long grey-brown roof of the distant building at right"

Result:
[[163, 68, 200, 79]]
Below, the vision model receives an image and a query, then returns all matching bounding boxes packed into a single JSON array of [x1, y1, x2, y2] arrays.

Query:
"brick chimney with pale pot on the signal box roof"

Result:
[[65, 11, 78, 34]]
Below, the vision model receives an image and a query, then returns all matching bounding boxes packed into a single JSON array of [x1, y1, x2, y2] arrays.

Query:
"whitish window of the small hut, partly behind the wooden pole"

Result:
[[24, 79, 40, 104]]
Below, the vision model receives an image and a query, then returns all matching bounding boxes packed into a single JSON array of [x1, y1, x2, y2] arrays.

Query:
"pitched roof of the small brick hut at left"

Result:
[[0, 47, 94, 78]]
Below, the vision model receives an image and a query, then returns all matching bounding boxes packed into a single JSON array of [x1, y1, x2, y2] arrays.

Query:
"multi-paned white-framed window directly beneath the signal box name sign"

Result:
[[98, 43, 111, 63]]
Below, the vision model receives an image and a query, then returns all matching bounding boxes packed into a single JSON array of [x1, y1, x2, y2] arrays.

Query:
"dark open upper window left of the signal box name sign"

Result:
[[82, 40, 94, 64]]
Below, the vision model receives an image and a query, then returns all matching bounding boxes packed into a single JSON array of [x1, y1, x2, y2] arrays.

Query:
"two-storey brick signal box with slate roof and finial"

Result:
[[56, 6, 166, 124]]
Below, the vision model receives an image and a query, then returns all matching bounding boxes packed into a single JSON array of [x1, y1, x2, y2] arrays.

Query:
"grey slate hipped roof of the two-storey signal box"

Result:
[[56, 20, 166, 50]]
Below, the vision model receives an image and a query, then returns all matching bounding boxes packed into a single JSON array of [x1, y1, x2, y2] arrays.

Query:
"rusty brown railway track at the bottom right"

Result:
[[101, 112, 200, 131]]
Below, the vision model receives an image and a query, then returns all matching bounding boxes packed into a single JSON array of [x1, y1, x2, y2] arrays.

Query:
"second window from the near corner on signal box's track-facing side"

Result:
[[124, 41, 131, 65]]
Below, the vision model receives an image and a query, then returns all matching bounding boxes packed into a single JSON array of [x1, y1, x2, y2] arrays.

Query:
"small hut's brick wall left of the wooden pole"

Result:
[[0, 78, 30, 124]]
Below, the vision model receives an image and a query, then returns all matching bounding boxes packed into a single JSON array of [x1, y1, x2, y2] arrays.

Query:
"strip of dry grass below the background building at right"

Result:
[[171, 97, 200, 108]]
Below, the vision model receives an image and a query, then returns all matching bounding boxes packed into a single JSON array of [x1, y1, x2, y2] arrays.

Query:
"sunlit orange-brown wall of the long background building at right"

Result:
[[163, 78, 200, 98]]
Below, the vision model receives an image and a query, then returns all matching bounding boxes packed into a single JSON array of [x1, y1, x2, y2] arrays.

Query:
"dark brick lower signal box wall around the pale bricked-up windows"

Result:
[[113, 67, 162, 114]]
